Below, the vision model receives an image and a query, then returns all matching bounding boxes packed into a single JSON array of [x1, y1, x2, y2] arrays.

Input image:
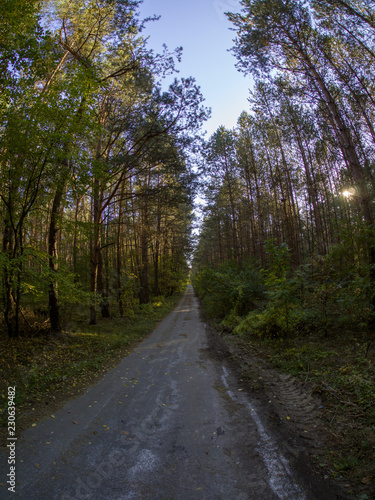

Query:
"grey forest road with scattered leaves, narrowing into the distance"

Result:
[[0, 287, 340, 500]]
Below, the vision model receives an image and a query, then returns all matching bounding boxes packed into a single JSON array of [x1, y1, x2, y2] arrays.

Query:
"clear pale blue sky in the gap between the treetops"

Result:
[[140, 0, 251, 138]]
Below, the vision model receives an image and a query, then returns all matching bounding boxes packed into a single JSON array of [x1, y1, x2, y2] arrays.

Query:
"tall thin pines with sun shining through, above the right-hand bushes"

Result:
[[195, 0, 375, 340]]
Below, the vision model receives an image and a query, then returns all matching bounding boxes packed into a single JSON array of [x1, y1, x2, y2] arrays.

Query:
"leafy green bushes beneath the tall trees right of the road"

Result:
[[234, 239, 371, 338]]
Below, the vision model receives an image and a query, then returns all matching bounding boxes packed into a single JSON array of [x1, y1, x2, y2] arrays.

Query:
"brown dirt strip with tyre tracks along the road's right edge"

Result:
[[206, 324, 362, 500]]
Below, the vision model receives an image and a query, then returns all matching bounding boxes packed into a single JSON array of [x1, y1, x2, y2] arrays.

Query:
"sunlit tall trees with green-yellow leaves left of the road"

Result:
[[0, 0, 207, 337]]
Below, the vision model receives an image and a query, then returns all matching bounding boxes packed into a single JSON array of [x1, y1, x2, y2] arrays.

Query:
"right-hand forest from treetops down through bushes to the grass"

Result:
[[193, 0, 375, 486]]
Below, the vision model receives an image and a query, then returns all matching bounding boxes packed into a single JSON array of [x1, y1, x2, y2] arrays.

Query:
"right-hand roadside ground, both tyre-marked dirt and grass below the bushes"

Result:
[[208, 323, 375, 500]]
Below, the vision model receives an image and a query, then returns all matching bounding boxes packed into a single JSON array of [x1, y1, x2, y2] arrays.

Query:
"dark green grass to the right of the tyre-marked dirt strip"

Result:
[[241, 332, 375, 500]]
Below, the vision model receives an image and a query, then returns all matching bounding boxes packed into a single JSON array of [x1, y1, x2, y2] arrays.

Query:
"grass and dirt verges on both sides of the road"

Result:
[[0, 297, 375, 500]]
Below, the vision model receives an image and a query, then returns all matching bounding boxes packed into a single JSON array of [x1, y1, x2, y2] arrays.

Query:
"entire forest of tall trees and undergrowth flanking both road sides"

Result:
[[0, 0, 375, 492]]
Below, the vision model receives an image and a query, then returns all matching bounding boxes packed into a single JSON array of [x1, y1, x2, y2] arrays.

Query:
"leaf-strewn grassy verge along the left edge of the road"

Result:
[[0, 295, 181, 445]]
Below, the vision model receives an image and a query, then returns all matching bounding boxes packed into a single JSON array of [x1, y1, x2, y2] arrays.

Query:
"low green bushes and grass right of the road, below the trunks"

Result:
[[193, 242, 375, 499]]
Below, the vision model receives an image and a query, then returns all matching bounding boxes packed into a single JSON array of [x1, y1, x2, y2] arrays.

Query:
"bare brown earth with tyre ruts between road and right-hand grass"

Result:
[[207, 324, 375, 500]]
